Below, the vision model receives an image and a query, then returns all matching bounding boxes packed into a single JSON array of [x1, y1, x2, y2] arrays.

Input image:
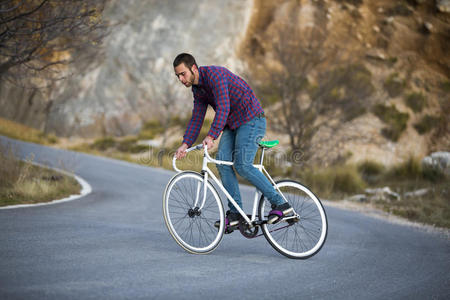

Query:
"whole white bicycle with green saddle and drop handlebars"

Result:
[[163, 141, 328, 259]]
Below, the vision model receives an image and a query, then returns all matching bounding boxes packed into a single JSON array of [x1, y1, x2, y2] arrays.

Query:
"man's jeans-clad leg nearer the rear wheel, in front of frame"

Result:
[[234, 117, 285, 205]]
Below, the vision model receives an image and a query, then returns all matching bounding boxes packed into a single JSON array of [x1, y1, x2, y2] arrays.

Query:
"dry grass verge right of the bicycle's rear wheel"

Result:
[[269, 157, 450, 228]]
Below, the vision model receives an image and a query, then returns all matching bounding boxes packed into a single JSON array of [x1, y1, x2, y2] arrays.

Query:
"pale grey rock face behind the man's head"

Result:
[[0, 0, 252, 137]]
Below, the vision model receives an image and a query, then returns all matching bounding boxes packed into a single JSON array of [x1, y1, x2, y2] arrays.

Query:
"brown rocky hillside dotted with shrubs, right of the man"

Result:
[[240, 0, 450, 164]]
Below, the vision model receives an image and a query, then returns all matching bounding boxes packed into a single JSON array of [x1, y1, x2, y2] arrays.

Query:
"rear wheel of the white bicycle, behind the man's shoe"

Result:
[[259, 180, 328, 259]]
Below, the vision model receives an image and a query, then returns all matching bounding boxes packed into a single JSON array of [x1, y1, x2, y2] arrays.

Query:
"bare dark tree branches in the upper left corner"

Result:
[[0, 0, 107, 83]]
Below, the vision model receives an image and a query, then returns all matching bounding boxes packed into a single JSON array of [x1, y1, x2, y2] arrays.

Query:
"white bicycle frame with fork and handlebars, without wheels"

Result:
[[172, 144, 288, 227]]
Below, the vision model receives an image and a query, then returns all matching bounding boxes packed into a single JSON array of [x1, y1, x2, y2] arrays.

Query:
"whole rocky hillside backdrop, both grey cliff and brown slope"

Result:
[[0, 0, 450, 164]]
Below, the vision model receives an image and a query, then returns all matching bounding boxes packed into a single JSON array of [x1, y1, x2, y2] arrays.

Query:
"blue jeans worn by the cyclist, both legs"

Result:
[[216, 117, 284, 212]]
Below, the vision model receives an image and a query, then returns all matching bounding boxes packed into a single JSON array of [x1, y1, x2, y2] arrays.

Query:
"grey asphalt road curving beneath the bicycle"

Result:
[[0, 138, 450, 299]]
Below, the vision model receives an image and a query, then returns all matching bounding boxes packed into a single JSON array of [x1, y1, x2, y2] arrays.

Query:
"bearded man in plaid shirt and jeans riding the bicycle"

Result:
[[173, 53, 293, 232]]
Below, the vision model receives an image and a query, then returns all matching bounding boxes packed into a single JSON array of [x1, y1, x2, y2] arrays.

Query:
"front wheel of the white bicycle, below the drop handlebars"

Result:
[[163, 171, 225, 254]]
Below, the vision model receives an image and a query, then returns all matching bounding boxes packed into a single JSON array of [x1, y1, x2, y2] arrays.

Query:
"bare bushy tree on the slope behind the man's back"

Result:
[[256, 1, 374, 161]]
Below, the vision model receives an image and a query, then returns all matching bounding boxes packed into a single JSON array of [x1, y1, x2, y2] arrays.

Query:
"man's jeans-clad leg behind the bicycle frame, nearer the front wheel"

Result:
[[216, 129, 242, 213]]
